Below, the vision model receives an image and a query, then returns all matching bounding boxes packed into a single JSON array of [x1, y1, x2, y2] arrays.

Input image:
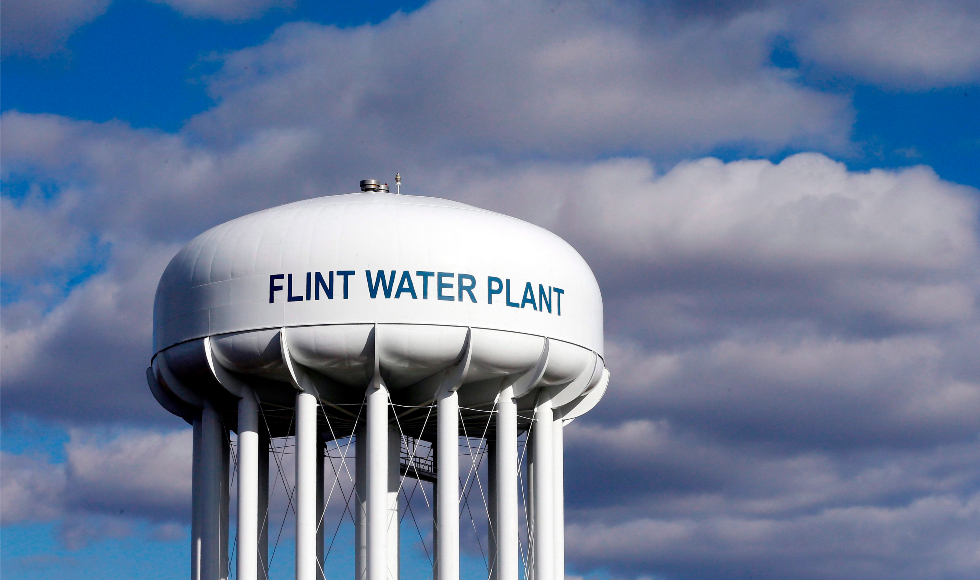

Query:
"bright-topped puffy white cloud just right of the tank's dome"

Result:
[[456, 153, 978, 274]]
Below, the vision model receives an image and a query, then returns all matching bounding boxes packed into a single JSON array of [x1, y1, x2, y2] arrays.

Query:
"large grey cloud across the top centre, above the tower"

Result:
[[190, 1, 852, 157]]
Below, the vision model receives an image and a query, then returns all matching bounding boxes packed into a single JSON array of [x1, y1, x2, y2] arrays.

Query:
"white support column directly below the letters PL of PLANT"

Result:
[[495, 386, 520, 580]]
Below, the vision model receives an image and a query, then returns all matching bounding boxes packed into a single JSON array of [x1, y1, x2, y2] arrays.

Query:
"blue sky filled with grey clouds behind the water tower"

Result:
[[0, 0, 980, 580]]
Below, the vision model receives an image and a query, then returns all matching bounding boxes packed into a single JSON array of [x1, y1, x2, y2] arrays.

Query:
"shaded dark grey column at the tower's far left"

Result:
[[191, 401, 228, 580]]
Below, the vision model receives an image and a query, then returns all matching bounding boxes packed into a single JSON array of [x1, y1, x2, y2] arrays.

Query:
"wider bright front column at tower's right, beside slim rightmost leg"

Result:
[[531, 393, 555, 580]]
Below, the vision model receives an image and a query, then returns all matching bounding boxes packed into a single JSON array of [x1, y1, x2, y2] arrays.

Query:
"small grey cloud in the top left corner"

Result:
[[0, 0, 112, 57]]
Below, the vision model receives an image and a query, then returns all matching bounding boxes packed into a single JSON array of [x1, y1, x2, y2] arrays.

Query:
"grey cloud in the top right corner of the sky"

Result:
[[645, 0, 980, 91]]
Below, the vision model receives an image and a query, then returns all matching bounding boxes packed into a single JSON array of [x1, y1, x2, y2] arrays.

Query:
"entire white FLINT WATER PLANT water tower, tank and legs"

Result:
[[147, 180, 609, 580]]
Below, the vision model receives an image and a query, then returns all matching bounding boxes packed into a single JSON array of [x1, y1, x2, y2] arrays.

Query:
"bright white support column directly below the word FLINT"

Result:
[[293, 392, 317, 580]]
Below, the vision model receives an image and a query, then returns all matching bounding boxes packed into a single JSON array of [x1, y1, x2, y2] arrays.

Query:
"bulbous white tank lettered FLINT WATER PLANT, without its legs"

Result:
[[153, 192, 604, 436]]
